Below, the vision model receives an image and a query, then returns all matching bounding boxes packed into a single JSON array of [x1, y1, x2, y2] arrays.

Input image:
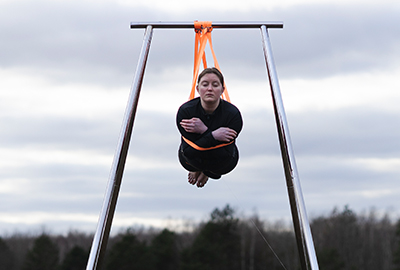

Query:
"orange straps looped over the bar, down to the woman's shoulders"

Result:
[[189, 21, 231, 102]]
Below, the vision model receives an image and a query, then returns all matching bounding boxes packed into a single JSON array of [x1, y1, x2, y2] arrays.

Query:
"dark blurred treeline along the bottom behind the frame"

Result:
[[0, 205, 400, 270]]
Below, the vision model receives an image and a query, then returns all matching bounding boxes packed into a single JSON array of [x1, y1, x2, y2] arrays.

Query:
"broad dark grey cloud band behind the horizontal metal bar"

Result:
[[0, 1, 400, 86]]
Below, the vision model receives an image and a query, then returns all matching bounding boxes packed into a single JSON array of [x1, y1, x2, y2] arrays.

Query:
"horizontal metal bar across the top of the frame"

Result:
[[131, 21, 283, 28]]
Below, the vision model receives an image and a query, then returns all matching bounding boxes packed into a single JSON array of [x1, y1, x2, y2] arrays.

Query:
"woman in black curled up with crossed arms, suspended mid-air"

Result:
[[176, 67, 243, 187]]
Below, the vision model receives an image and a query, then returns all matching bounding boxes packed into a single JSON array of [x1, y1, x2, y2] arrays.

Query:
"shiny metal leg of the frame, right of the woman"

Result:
[[261, 26, 319, 270]]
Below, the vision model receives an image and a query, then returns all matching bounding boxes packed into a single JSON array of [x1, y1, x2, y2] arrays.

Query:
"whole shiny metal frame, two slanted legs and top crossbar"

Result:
[[86, 22, 319, 270]]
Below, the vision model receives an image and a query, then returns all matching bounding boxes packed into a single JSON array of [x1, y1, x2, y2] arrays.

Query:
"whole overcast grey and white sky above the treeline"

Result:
[[0, 0, 400, 234]]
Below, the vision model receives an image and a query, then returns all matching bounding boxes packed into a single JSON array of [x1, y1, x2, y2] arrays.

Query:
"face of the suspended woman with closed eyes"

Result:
[[197, 73, 224, 103]]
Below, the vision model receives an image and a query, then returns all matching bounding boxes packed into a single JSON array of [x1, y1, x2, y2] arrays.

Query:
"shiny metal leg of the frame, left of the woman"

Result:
[[86, 25, 153, 270]]
